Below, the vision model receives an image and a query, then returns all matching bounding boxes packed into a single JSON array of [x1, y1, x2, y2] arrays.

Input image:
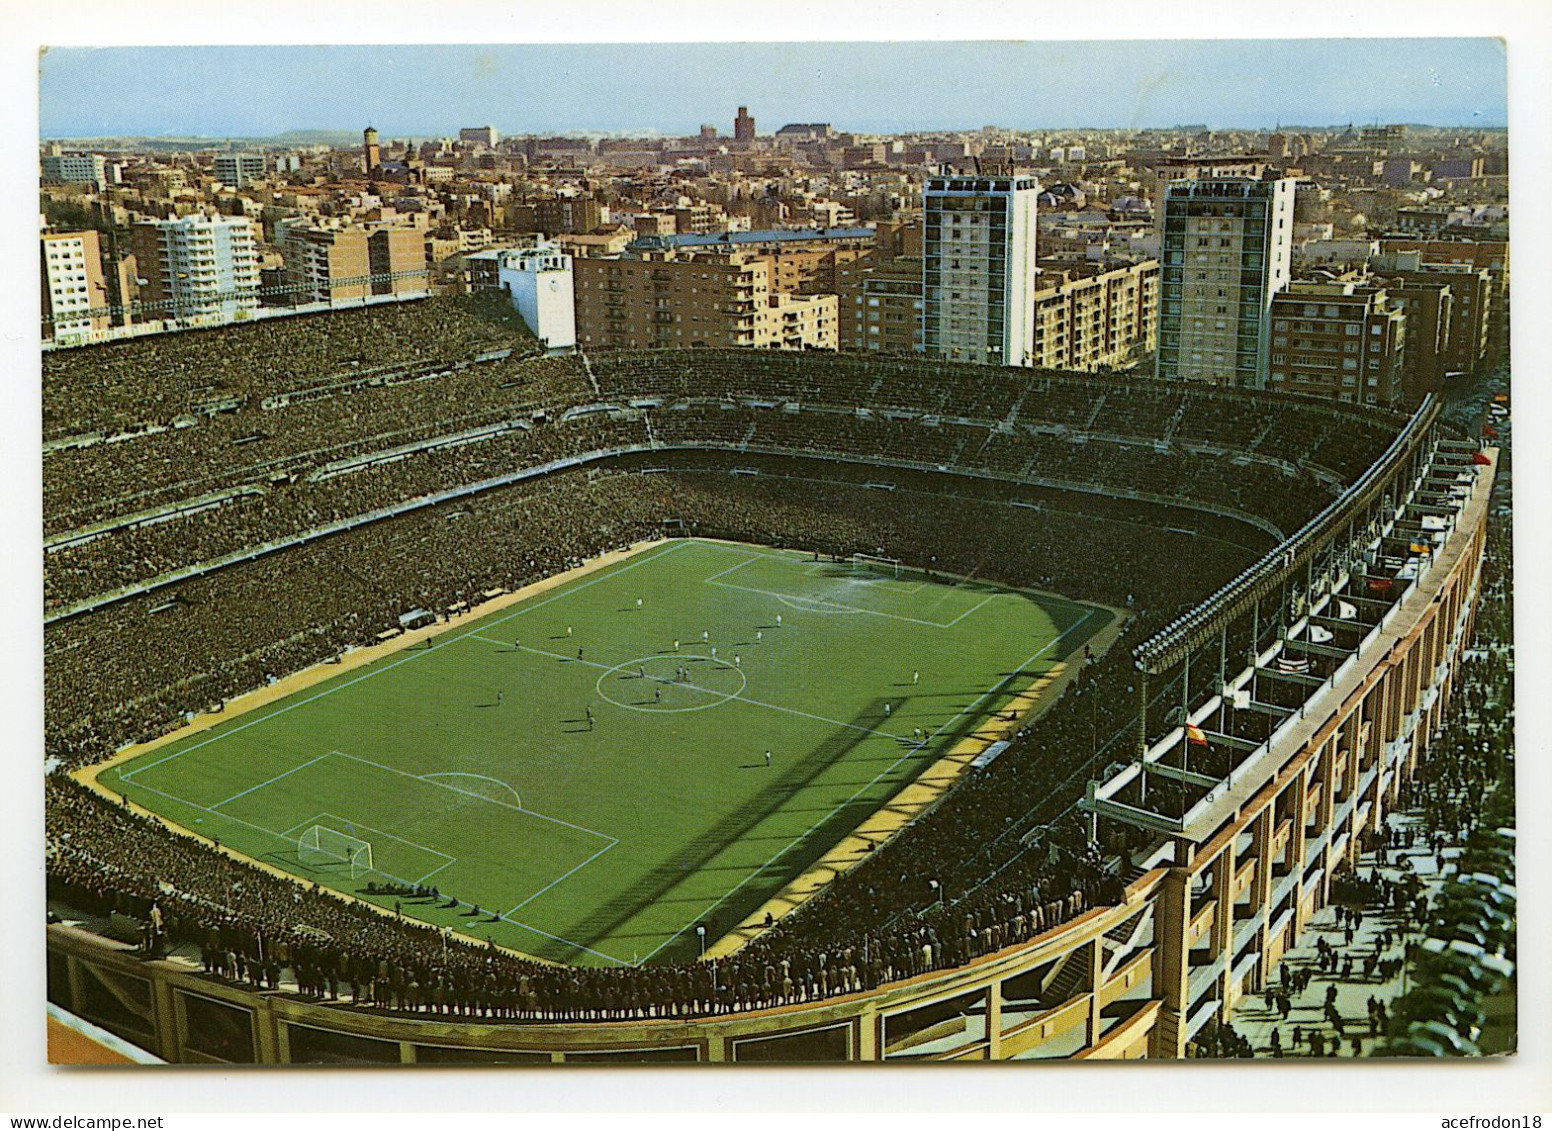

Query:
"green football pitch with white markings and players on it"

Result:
[[101, 540, 1111, 965]]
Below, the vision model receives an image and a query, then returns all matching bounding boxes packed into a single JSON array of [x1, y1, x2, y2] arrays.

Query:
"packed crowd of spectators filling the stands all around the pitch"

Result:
[[45, 313, 1427, 1019]]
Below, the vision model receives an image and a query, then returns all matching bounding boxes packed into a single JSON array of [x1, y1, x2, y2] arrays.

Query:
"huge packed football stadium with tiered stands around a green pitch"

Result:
[[43, 295, 1513, 1064]]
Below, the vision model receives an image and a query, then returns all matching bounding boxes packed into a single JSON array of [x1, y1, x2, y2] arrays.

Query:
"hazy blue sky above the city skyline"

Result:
[[40, 39, 1507, 138]]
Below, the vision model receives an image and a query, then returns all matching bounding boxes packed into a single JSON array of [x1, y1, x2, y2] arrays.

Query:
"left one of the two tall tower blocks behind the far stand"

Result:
[[922, 174, 1040, 365]]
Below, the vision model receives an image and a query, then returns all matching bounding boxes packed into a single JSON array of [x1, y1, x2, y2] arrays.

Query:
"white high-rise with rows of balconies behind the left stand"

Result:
[[130, 216, 259, 324]]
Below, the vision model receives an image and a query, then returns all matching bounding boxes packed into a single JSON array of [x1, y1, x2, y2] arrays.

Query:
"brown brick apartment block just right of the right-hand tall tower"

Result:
[[1270, 282, 1406, 408]]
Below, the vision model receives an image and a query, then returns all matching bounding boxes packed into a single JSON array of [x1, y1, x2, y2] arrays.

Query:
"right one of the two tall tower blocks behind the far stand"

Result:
[[1156, 177, 1294, 389]]
